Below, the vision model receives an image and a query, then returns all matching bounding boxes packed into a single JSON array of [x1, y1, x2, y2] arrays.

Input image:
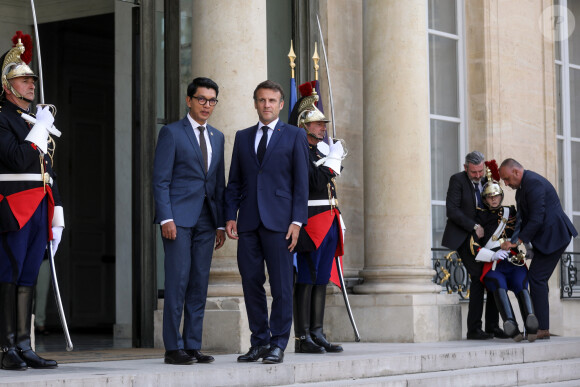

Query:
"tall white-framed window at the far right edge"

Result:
[[552, 0, 580, 251]]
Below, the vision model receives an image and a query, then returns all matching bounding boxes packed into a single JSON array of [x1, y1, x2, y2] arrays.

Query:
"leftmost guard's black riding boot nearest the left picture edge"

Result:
[[0, 282, 28, 370]]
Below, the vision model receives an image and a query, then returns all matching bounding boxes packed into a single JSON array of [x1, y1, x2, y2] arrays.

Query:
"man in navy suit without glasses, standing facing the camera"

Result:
[[226, 81, 308, 363]]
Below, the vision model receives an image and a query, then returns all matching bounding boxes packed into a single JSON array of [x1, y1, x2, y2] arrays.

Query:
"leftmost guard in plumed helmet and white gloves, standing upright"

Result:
[[0, 31, 64, 370]]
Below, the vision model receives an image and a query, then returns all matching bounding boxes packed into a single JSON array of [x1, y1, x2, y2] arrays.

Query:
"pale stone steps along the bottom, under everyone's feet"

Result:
[[0, 337, 580, 387]]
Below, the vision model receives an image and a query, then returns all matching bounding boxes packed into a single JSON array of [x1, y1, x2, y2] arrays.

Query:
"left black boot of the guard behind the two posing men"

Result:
[[294, 283, 326, 353]]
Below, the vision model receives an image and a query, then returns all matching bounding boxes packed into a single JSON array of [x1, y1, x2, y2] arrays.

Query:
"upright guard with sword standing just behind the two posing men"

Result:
[[292, 84, 345, 353]]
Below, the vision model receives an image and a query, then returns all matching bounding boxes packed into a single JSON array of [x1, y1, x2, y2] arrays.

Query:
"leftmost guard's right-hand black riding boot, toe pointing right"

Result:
[[16, 286, 58, 368]]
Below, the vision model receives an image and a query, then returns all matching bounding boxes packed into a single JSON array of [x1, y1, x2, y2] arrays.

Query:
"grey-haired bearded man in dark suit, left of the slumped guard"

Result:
[[441, 151, 507, 340]]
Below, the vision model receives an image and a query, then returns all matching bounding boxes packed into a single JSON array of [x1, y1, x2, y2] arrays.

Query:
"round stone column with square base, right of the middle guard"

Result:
[[326, 0, 461, 342]]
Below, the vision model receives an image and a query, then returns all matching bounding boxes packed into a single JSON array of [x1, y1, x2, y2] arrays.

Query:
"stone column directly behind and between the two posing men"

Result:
[[192, 0, 268, 297]]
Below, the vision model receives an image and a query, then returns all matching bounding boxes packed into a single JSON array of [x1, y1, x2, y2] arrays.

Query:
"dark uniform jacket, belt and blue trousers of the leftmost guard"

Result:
[[0, 100, 62, 286]]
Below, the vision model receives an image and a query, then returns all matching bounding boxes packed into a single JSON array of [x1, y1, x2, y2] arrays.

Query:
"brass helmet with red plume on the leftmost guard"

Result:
[[0, 31, 38, 98]]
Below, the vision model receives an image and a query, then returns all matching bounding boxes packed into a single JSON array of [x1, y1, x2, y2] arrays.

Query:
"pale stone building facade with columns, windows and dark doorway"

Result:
[[0, 0, 580, 352]]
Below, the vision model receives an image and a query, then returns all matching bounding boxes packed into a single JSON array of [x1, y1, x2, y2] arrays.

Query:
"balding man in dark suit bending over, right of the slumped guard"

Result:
[[499, 159, 578, 339]]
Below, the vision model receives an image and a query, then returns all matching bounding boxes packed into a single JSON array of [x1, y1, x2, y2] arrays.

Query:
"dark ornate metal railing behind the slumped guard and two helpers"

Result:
[[431, 248, 580, 299]]
